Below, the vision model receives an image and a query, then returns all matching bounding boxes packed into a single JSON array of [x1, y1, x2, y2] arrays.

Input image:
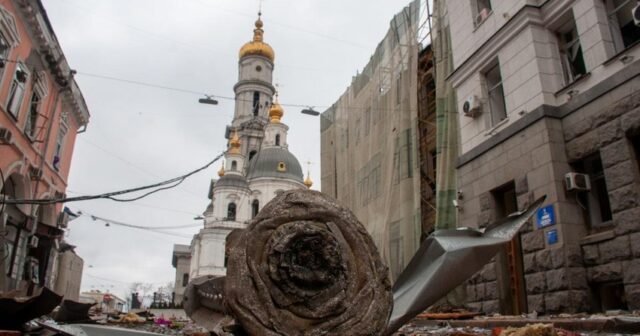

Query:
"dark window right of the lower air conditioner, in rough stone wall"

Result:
[[574, 153, 612, 229]]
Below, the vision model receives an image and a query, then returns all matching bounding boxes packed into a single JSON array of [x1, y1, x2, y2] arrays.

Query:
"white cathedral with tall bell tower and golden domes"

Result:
[[178, 15, 312, 284]]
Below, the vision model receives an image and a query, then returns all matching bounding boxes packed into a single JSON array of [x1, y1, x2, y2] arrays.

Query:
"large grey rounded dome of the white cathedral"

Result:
[[247, 147, 303, 183]]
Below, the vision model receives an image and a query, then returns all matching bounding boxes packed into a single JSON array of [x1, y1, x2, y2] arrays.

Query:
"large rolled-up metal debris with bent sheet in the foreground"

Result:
[[185, 190, 544, 335]]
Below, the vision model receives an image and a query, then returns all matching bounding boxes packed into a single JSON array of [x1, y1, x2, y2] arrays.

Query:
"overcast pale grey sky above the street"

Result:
[[43, 0, 418, 296]]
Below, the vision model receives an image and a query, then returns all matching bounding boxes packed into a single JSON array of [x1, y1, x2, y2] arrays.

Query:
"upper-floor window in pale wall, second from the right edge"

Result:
[[557, 15, 587, 85]]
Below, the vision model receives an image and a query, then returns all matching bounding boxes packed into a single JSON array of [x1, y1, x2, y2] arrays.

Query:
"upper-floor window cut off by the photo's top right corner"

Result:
[[606, 0, 640, 52]]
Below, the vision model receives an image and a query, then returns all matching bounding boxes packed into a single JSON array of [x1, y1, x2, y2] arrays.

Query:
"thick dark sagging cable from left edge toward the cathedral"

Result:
[[2, 152, 224, 204]]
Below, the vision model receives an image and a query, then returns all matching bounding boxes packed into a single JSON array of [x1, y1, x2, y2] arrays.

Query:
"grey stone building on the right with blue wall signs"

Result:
[[436, 0, 640, 314]]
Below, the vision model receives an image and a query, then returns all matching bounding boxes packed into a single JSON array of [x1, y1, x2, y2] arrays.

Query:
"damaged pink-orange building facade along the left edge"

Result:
[[0, 0, 89, 297]]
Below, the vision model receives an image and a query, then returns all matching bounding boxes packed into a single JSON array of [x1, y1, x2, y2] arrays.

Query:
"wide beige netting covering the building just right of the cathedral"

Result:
[[321, 0, 421, 279]]
